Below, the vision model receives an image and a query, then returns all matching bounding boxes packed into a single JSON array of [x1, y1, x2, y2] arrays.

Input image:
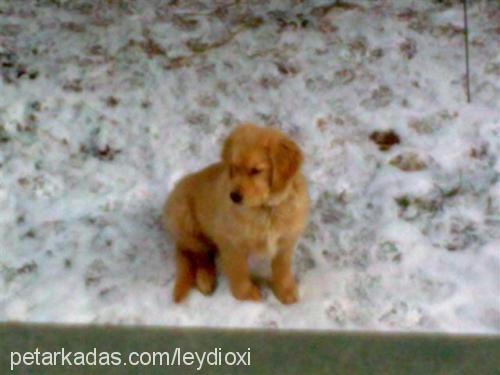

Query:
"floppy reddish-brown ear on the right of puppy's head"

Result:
[[270, 136, 304, 191]]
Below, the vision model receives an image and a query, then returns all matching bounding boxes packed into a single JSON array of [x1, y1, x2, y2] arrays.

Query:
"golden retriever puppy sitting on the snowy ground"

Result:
[[162, 124, 309, 304]]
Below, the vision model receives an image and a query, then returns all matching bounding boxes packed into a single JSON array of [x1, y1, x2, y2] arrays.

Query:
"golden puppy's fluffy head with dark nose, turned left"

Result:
[[222, 124, 303, 207]]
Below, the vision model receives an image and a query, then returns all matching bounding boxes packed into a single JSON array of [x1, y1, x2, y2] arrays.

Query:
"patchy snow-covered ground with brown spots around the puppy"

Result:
[[0, 0, 500, 333]]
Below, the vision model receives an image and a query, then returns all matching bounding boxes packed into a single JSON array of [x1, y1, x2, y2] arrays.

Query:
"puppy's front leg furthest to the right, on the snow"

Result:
[[271, 239, 298, 304]]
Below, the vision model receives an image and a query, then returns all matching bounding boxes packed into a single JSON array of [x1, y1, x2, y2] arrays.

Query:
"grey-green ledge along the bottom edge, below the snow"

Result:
[[0, 324, 500, 375]]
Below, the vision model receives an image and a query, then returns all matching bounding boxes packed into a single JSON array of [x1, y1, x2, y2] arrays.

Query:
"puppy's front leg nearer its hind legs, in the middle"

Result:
[[220, 248, 261, 301]]
